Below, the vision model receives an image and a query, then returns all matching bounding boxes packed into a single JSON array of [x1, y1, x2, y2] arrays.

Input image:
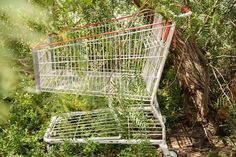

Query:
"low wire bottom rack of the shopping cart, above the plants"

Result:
[[44, 107, 163, 144]]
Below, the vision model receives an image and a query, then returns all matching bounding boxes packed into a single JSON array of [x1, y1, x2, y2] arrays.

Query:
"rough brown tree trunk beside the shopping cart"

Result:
[[170, 30, 217, 145]]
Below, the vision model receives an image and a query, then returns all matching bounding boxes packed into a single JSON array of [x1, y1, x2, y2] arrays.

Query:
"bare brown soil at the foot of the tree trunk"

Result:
[[158, 125, 236, 157]]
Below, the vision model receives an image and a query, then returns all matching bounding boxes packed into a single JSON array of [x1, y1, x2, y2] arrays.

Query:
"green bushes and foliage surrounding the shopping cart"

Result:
[[0, 0, 236, 157]]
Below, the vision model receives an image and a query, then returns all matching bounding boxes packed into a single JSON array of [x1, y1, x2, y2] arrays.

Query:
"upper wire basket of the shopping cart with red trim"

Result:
[[34, 11, 174, 100]]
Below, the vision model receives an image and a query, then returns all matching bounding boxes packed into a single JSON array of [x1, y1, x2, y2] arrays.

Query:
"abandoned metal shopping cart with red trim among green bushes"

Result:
[[33, 5, 192, 156]]
